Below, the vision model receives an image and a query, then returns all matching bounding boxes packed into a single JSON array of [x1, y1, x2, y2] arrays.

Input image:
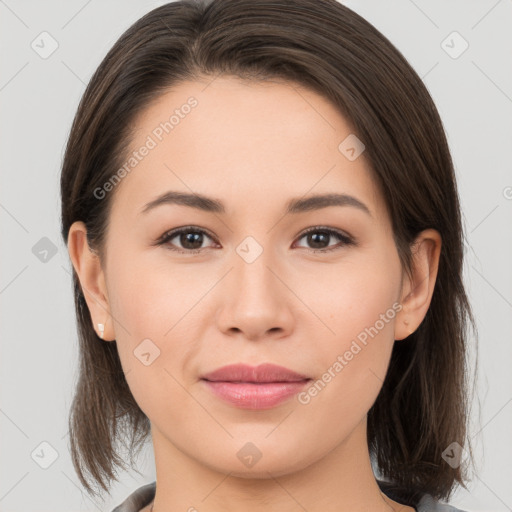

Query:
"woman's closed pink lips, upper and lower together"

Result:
[[202, 364, 311, 409]]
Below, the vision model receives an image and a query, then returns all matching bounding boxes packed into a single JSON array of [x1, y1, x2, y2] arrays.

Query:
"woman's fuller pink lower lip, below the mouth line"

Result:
[[203, 380, 309, 409]]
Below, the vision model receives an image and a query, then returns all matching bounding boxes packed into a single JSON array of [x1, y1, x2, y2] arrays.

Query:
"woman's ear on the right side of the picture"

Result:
[[395, 229, 442, 340]]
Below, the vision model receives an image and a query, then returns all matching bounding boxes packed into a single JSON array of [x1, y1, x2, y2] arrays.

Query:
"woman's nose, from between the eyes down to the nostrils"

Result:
[[216, 246, 297, 341]]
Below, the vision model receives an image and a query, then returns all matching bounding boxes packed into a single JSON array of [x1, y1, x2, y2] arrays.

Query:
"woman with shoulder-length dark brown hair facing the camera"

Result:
[[61, 0, 474, 512]]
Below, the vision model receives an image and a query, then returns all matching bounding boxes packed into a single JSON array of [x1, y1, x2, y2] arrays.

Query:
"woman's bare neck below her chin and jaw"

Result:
[[147, 418, 414, 512]]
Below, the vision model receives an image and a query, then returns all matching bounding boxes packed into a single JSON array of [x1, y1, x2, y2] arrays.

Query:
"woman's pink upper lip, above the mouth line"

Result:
[[202, 363, 309, 382]]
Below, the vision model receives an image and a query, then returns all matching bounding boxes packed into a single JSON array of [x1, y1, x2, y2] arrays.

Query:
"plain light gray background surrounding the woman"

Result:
[[0, 0, 512, 512]]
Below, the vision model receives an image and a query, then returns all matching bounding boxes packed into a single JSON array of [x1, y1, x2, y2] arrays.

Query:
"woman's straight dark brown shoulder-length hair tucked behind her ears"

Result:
[[61, 0, 476, 506]]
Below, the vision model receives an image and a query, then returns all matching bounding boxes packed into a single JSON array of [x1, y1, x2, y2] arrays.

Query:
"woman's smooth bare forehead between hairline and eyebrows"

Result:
[[110, 77, 384, 224]]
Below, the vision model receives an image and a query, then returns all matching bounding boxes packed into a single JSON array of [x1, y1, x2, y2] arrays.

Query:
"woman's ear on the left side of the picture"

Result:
[[68, 221, 115, 341]]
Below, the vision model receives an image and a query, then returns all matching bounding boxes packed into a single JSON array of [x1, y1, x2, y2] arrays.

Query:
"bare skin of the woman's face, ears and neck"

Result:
[[68, 76, 441, 512]]
